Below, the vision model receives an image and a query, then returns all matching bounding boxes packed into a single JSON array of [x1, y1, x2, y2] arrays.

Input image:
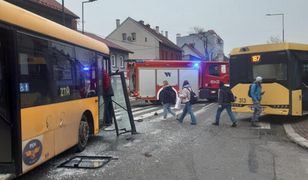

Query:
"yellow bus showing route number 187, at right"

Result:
[[230, 43, 308, 116]]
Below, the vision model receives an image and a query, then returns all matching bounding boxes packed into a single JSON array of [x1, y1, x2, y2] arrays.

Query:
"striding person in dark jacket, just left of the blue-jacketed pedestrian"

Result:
[[213, 82, 237, 127]]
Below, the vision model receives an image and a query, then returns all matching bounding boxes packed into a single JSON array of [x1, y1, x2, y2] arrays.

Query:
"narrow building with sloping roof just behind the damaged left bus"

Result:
[[84, 32, 133, 72]]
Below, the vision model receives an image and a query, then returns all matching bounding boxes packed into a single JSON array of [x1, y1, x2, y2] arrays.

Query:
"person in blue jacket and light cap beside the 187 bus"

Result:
[[249, 76, 264, 127]]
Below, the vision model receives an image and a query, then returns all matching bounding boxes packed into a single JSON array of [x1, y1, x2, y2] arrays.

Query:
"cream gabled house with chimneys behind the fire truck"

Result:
[[106, 17, 182, 59]]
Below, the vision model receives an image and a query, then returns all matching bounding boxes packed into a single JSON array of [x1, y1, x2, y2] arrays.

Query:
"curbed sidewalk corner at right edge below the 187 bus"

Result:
[[283, 119, 308, 149]]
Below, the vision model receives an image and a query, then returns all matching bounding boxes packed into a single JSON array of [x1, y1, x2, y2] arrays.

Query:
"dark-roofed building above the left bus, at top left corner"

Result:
[[5, 0, 79, 30]]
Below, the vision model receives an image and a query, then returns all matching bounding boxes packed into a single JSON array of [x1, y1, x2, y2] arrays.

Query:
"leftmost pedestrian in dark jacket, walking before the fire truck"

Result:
[[159, 80, 176, 119]]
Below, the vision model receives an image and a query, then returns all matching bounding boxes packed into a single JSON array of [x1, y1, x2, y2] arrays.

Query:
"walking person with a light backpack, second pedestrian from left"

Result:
[[177, 80, 197, 125]]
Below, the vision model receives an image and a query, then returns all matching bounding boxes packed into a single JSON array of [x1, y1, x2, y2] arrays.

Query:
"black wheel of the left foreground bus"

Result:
[[76, 115, 90, 152]]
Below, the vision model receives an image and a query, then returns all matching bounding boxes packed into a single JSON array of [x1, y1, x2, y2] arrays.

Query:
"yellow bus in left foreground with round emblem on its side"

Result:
[[0, 1, 109, 176]]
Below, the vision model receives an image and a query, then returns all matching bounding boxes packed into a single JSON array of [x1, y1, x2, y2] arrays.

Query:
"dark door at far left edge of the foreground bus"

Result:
[[0, 26, 13, 167]]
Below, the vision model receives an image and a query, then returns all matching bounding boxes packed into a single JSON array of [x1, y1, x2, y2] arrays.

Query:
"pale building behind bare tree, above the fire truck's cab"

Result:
[[176, 30, 225, 61]]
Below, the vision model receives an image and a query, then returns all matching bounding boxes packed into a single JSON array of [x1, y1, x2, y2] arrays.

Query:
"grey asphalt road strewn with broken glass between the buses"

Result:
[[20, 104, 308, 180]]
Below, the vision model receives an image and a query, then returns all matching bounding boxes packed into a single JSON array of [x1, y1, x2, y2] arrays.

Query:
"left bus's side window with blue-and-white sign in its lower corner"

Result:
[[18, 34, 52, 107]]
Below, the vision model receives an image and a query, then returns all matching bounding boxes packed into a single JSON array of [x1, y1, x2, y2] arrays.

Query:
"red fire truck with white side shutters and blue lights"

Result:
[[127, 60, 229, 101]]
